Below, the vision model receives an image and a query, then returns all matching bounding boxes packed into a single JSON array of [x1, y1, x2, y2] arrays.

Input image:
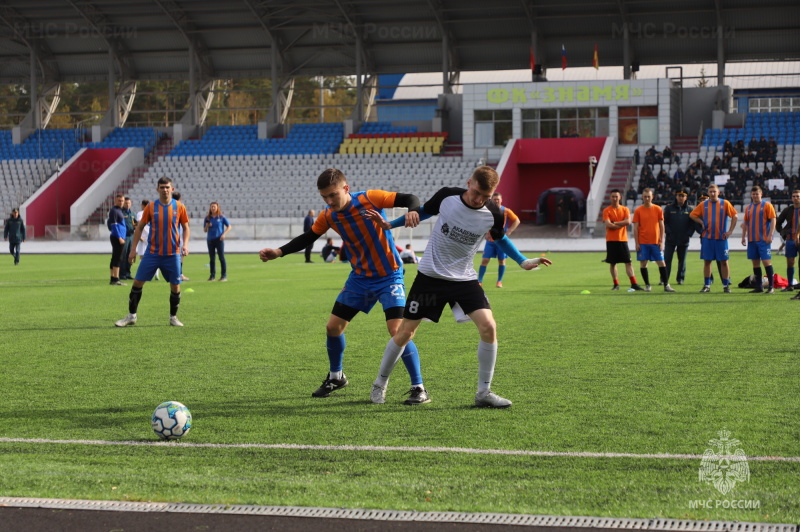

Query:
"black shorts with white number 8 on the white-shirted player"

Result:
[[403, 273, 492, 322]]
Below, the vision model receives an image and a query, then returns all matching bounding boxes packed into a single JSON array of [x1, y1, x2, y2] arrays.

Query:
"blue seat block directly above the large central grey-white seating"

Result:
[[172, 123, 344, 156]]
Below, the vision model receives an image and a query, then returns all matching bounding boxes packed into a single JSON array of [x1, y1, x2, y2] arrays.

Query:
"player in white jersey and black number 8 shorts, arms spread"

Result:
[[370, 166, 551, 408]]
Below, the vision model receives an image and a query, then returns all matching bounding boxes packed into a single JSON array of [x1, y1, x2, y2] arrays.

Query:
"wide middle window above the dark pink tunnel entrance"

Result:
[[522, 107, 608, 139]]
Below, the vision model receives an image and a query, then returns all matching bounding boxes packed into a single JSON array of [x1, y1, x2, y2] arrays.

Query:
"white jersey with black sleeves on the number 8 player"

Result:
[[418, 188, 505, 281]]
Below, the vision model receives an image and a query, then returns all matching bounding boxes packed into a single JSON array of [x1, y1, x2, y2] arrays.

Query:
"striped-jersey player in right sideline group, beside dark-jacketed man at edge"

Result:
[[742, 187, 777, 294]]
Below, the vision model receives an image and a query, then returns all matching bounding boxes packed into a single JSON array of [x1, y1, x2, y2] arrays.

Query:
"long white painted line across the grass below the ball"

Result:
[[0, 437, 800, 462]]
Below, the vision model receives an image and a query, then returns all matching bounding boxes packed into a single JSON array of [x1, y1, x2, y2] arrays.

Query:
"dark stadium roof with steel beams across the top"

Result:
[[0, 0, 800, 83]]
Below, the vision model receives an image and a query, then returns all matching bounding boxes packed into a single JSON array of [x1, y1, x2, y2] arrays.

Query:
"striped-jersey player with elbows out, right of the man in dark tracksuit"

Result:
[[689, 184, 739, 294]]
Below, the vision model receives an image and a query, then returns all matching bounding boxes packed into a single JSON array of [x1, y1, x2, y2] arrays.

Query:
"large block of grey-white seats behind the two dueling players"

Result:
[[130, 153, 475, 218]]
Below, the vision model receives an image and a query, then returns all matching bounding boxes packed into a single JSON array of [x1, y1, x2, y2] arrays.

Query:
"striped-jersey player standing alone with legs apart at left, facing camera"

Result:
[[115, 177, 189, 327]]
